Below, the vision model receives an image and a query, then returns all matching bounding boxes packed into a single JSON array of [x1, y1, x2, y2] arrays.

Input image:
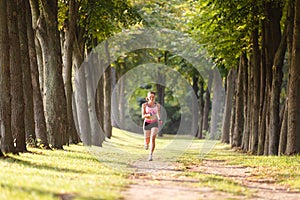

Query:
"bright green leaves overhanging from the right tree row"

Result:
[[189, 0, 263, 68]]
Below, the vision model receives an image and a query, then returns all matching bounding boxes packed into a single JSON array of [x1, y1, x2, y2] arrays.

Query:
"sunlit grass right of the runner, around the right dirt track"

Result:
[[178, 140, 300, 196]]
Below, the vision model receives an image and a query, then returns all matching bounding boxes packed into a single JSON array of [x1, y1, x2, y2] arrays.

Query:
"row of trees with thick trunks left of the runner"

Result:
[[0, 0, 138, 155]]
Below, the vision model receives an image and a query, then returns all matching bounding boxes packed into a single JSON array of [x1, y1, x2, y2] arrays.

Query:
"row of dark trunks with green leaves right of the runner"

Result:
[[191, 0, 300, 155]]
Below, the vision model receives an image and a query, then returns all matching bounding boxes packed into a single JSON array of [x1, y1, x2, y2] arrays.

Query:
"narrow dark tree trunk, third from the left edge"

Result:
[[18, 1, 36, 146]]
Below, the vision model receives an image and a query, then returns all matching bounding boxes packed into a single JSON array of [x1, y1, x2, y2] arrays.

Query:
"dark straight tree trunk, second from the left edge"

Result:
[[7, 0, 27, 152]]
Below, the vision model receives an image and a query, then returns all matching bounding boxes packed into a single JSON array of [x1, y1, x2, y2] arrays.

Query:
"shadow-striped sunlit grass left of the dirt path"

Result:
[[0, 145, 129, 200]]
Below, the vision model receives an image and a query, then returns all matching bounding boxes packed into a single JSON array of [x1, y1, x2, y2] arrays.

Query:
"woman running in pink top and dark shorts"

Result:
[[142, 92, 162, 161]]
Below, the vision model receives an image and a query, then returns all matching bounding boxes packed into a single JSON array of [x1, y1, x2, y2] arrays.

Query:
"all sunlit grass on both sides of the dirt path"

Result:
[[0, 129, 300, 200]]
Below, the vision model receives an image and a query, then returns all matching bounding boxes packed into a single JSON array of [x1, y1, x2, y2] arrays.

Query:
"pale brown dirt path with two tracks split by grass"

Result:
[[122, 160, 300, 200]]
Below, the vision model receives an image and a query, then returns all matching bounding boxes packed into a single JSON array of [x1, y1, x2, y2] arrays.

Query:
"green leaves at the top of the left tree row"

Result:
[[58, 0, 141, 47]]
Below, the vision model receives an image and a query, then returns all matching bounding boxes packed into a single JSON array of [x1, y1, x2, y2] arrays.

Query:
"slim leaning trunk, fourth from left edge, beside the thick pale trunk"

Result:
[[25, 1, 49, 148]]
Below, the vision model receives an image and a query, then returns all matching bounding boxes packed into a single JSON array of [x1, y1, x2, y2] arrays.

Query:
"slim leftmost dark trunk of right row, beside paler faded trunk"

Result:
[[232, 54, 248, 147]]
